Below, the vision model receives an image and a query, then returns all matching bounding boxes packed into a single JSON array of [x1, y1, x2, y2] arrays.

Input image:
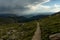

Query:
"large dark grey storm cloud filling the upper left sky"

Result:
[[0, 0, 45, 14]]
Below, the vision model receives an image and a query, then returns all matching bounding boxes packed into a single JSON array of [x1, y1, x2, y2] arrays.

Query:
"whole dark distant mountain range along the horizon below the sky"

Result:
[[0, 12, 59, 23]]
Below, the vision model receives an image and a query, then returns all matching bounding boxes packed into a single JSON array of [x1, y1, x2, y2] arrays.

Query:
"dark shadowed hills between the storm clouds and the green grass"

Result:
[[0, 14, 49, 23]]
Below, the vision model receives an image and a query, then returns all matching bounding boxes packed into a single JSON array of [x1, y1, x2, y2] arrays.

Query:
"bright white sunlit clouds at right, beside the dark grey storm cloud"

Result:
[[27, 0, 60, 13]]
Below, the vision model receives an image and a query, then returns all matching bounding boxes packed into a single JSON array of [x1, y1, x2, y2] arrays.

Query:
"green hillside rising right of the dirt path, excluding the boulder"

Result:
[[39, 12, 60, 40]]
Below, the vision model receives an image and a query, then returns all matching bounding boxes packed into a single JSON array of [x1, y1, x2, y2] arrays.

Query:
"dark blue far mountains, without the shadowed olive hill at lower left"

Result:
[[0, 14, 49, 22]]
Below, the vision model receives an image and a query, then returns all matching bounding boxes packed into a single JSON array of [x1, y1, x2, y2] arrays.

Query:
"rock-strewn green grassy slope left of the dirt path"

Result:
[[0, 19, 36, 40]]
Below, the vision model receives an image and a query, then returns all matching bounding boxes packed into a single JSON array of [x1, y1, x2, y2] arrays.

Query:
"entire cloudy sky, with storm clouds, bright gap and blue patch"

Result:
[[0, 0, 60, 15]]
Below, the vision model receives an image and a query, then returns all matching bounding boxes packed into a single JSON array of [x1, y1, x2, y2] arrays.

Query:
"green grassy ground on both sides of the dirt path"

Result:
[[0, 14, 60, 40]]
